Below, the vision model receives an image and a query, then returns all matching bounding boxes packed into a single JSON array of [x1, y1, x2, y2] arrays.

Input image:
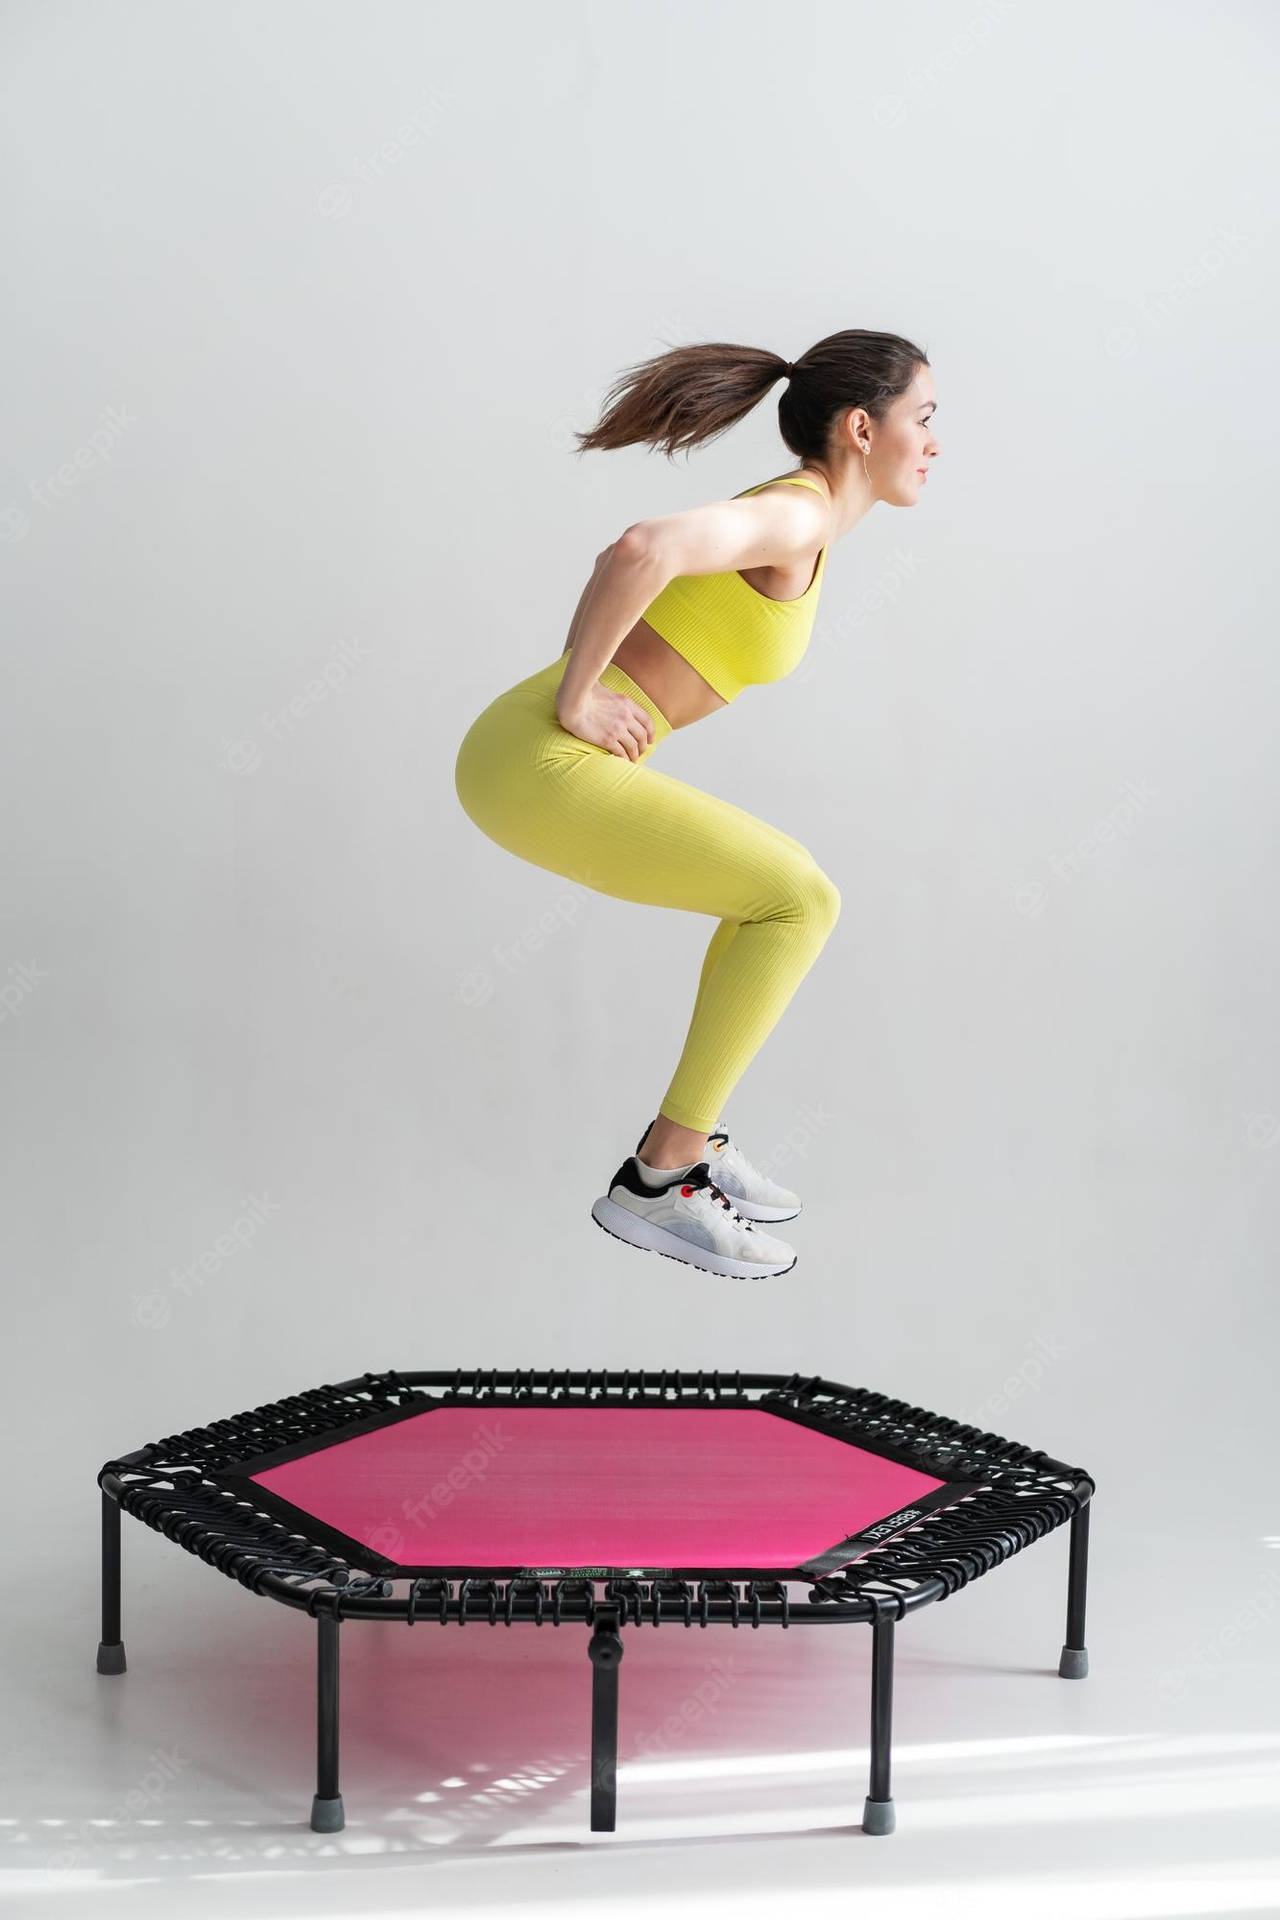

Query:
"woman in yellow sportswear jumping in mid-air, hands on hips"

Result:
[[455, 328, 938, 1277]]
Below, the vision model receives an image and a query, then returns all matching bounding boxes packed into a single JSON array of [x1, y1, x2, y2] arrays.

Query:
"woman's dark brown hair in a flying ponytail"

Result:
[[574, 326, 929, 459]]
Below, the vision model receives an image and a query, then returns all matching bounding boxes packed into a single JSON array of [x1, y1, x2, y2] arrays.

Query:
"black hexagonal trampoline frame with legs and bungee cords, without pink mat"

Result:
[[98, 1369, 1096, 1834]]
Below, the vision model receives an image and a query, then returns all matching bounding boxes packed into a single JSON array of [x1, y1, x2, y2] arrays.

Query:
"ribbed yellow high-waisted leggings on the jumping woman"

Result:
[[455, 653, 841, 1133]]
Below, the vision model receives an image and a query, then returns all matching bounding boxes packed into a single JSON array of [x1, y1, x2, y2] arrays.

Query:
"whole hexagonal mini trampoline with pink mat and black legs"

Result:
[[98, 1371, 1094, 1834]]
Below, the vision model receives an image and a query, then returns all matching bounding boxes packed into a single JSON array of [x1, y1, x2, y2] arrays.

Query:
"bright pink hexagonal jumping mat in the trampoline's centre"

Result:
[[251, 1405, 960, 1571]]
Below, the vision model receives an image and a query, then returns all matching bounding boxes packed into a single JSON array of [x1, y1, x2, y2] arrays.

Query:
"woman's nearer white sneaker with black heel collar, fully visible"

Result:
[[591, 1154, 796, 1281]]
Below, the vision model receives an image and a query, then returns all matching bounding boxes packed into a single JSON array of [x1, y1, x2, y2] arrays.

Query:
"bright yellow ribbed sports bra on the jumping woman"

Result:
[[643, 474, 827, 701]]
